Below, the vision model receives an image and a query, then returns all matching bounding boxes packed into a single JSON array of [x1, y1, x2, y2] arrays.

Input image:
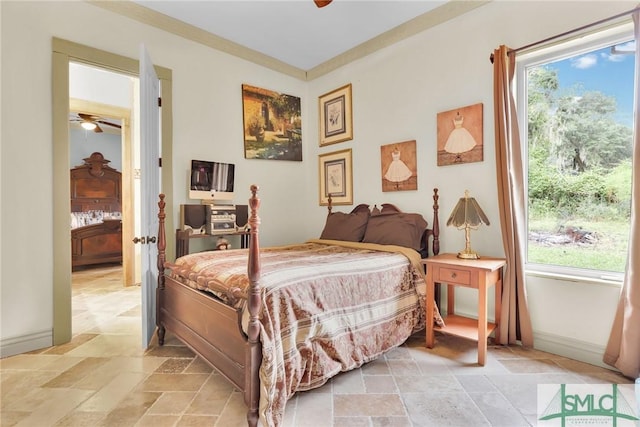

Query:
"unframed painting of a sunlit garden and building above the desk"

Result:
[[242, 85, 302, 162]]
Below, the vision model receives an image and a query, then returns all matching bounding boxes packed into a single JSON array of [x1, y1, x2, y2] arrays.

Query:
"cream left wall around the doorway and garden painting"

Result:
[[0, 1, 315, 354]]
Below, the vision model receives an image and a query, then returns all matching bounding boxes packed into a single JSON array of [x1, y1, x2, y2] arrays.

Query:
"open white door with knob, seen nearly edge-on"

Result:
[[140, 45, 160, 348]]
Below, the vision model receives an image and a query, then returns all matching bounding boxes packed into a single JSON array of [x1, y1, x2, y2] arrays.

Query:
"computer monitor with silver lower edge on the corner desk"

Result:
[[189, 160, 235, 203]]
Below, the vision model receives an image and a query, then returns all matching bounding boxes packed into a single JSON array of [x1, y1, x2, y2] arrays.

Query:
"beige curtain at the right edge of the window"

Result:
[[604, 11, 640, 378]]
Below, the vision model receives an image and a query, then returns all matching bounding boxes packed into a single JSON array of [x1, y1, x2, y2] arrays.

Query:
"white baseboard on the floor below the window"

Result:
[[533, 332, 615, 369]]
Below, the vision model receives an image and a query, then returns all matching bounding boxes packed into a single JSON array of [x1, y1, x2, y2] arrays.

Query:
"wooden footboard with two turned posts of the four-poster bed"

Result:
[[156, 185, 262, 426]]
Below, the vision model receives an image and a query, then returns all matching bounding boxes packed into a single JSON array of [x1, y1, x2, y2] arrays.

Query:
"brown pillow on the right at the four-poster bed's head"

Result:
[[362, 213, 428, 251]]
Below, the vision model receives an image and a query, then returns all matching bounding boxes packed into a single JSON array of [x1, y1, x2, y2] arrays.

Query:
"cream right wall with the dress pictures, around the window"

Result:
[[302, 1, 635, 370]]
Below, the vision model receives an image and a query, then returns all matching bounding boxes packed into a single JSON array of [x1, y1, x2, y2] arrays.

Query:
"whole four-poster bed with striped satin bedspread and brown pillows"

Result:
[[156, 186, 442, 426]]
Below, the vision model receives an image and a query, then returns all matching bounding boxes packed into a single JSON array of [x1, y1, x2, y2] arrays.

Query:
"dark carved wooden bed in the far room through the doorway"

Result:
[[70, 152, 122, 270]]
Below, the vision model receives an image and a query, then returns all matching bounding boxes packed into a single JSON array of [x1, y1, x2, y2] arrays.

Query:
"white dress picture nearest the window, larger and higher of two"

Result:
[[437, 104, 484, 166]]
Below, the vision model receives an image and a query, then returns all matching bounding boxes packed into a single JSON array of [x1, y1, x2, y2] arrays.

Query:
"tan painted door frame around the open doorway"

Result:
[[52, 37, 175, 345]]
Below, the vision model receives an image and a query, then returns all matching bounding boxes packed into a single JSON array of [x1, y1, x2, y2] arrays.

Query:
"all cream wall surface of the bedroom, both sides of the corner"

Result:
[[0, 1, 635, 363]]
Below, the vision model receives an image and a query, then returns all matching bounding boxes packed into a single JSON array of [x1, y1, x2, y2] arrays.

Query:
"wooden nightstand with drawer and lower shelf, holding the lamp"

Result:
[[422, 254, 506, 365]]
